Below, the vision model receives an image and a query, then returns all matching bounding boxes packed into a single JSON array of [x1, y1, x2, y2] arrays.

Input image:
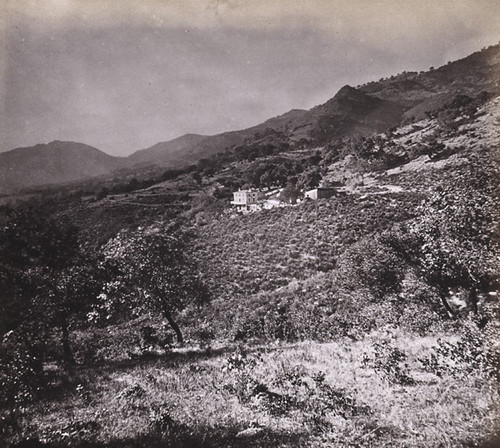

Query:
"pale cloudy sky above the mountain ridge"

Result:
[[0, 0, 500, 156]]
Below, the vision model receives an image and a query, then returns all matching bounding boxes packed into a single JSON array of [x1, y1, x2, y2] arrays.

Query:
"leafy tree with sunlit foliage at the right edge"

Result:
[[386, 165, 499, 314]]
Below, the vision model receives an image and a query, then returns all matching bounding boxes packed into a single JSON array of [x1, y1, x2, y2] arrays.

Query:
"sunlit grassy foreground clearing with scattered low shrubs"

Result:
[[8, 328, 500, 447]]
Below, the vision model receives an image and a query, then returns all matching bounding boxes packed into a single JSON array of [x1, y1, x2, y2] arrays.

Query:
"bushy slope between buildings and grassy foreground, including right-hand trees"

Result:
[[186, 142, 498, 340]]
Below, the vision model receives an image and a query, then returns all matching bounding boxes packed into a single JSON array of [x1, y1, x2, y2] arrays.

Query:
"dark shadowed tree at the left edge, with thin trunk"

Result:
[[0, 210, 104, 364]]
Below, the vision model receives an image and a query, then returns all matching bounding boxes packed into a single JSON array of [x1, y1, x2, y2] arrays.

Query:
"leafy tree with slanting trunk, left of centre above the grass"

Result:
[[104, 226, 208, 343]]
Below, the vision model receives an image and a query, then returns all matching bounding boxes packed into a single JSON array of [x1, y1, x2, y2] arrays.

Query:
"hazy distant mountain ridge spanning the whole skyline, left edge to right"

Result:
[[0, 44, 500, 193]]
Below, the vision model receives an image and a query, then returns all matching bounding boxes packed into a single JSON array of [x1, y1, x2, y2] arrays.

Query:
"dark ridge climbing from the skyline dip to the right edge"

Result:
[[130, 45, 500, 166]]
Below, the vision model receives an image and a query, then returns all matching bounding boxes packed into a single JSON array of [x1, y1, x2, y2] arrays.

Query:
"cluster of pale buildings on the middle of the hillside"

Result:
[[231, 187, 337, 213]]
